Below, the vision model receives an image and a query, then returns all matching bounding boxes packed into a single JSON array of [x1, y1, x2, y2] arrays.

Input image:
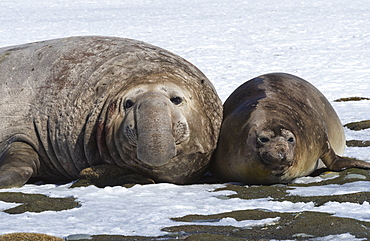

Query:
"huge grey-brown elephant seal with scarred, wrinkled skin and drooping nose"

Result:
[[0, 36, 222, 187]]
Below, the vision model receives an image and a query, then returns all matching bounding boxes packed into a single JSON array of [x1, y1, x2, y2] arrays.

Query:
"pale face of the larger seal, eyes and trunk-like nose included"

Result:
[[118, 80, 193, 168]]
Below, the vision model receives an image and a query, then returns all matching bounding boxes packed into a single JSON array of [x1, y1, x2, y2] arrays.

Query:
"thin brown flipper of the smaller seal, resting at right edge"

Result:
[[321, 149, 370, 171]]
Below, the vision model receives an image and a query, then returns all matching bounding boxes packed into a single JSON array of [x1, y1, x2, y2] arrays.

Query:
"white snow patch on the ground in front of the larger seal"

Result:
[[0, 183, 306, 236]]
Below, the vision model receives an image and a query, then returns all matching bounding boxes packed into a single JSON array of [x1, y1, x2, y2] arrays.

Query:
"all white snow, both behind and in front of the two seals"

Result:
[[0, 0, 370, 239]]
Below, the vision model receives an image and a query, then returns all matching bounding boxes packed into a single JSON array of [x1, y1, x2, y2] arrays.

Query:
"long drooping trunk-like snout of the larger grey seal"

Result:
[[123, 91, 190, 167]]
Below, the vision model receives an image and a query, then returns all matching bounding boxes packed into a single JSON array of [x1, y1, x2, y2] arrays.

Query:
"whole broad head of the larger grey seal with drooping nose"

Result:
[[98, 72, 221, 184]]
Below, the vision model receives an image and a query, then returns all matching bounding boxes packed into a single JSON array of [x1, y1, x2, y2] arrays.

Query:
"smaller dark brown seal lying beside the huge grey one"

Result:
[[211, 73, 370, 184]]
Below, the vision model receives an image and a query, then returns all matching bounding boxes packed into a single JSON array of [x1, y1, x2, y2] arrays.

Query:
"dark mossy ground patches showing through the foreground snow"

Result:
[[0, 169, 370, 241]]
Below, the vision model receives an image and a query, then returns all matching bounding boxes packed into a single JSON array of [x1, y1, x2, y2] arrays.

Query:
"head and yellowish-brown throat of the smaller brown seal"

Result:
[[236, 111, 300, 184]]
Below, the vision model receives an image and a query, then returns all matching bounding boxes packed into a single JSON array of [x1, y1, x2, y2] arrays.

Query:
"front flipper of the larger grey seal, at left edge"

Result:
[[0, 142, 40, 188]]
